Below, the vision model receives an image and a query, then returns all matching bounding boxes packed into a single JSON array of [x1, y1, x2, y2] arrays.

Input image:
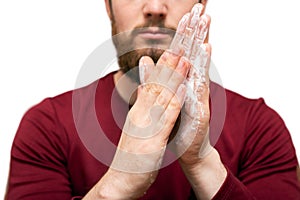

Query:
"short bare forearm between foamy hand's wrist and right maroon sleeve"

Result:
[[181, 149, 227, 199]]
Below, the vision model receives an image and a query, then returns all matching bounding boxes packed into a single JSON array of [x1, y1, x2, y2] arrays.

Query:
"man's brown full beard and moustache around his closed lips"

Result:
[[112, 20, 176, 84]]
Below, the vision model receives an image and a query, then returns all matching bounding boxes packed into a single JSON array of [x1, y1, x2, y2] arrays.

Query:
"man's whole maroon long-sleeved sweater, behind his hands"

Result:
[[5, 73, 300, 200]]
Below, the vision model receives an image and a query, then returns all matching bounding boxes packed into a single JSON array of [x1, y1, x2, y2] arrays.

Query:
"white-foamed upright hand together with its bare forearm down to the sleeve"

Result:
[[169, 4, 227, 199]]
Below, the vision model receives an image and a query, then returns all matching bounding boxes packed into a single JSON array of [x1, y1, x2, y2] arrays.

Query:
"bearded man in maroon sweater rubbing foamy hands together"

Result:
[[6, 0, 300, 199]]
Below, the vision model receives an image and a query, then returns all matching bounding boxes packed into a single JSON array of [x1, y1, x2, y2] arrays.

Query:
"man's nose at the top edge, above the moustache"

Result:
[[143, 0, 167, 22]]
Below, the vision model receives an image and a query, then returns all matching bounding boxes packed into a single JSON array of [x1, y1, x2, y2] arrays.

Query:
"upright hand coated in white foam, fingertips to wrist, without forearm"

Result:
[[171, 4, 212, 166]]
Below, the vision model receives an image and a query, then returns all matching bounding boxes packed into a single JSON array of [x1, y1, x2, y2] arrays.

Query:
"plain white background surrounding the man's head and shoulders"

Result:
[[0, 0, 300, 198]]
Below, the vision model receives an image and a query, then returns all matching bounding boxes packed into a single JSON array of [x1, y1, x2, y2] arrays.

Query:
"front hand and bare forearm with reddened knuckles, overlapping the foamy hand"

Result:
[[89, 48, 190, 199]]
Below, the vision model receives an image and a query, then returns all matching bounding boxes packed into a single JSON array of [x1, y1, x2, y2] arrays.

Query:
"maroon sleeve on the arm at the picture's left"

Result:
[[5, 99, 72, 200]]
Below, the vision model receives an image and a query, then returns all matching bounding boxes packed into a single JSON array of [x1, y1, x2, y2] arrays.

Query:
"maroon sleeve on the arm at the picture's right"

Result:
[[214, 99, 300, 200]]
